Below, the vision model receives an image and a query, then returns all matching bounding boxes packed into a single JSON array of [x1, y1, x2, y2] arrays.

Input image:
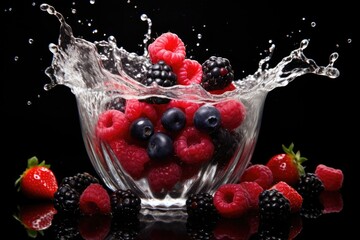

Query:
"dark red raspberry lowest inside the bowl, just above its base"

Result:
[[148, 162, 181, 192]]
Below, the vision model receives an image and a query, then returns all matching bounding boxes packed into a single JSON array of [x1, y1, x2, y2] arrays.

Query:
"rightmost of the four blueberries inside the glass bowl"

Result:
[[194, 105, 221, 133]]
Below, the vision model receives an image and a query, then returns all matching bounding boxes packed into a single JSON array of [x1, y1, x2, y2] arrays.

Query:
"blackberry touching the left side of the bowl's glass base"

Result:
[[110, 189, 141, 218]]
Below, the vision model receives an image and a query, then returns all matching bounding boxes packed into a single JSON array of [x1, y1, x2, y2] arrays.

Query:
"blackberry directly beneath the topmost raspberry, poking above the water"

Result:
[[141, 60, 177, 104]]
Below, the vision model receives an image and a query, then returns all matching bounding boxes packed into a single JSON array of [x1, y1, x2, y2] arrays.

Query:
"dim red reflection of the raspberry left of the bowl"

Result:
[[78, 215, 111, 240]]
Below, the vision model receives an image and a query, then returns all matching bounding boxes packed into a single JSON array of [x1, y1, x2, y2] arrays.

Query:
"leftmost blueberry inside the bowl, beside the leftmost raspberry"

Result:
[[130, 117, 154, 140]]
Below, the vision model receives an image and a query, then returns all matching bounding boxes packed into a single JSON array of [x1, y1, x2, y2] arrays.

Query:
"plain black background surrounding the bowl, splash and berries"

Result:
[[0, 0, 359, 239]]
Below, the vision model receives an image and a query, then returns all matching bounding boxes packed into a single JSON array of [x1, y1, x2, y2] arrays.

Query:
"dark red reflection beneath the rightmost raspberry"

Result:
[[319, 191, 344, 214]]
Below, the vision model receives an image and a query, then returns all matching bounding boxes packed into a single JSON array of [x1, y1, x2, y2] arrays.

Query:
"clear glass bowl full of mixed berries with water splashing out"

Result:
[[42, 4, 339, 210]]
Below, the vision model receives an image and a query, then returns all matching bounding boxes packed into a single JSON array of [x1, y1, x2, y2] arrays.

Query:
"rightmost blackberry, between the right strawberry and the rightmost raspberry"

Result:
[[296, 173, 324, 198]]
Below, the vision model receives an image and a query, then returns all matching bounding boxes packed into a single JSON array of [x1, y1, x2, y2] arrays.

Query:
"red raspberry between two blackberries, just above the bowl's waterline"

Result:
[[175, 59, 202, 85]]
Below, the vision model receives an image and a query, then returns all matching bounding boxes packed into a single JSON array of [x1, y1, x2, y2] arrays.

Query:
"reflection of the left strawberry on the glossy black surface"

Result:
[[14, 202, 56, 238]]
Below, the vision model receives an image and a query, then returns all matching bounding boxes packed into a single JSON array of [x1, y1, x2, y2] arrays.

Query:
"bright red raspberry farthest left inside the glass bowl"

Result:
[[96, 110, 130, 141]]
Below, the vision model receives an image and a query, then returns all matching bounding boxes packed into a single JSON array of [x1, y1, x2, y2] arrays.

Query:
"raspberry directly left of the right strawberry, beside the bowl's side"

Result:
[[240, 164, 273, 189]]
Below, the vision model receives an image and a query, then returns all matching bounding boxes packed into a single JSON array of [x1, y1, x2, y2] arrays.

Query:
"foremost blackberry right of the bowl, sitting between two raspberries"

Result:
[[259, 189, 290, 221]]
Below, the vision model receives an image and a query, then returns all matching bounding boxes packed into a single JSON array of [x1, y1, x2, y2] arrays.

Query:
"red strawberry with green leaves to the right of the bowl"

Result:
[[266, 143, 307, 186]]
